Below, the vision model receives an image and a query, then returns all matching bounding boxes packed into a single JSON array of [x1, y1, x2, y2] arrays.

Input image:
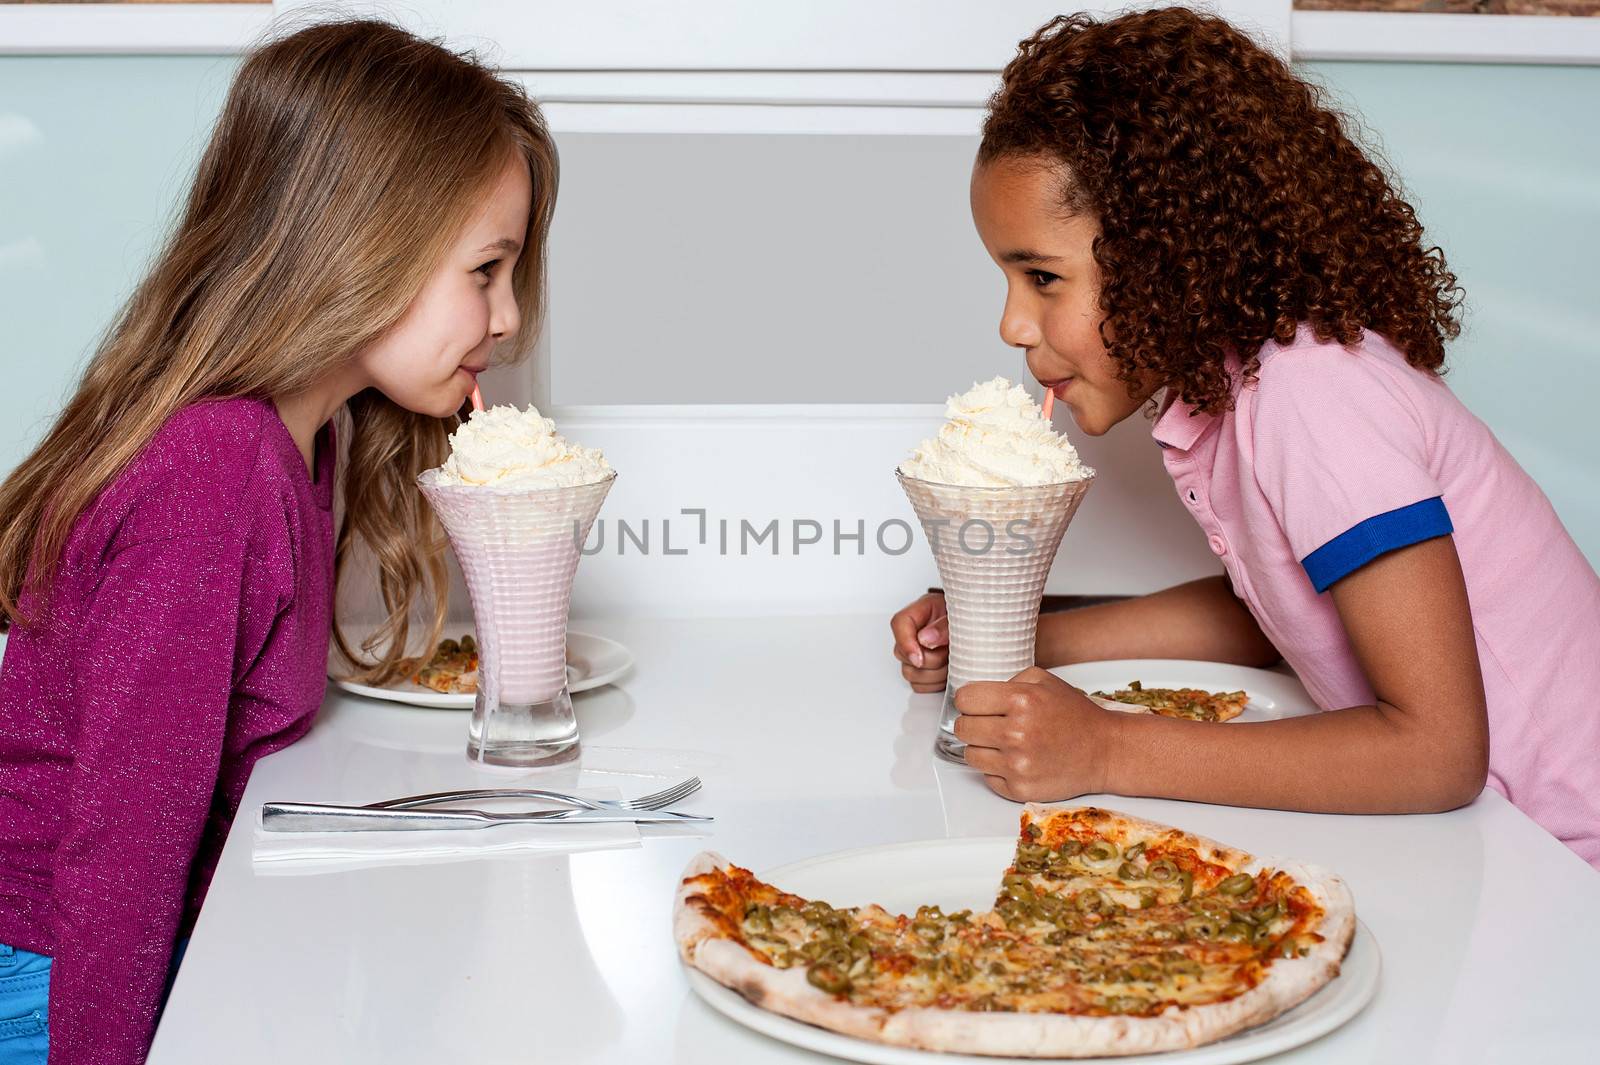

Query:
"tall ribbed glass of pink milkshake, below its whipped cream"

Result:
[[418, 470, 616, 766]]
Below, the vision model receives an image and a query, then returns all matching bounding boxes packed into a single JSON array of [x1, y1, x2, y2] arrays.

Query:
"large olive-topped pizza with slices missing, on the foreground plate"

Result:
[[674, 804, 1355, 1057]]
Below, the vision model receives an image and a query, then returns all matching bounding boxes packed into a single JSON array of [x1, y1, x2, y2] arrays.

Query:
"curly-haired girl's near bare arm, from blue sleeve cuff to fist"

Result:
[[955, 536, 1488, 814]]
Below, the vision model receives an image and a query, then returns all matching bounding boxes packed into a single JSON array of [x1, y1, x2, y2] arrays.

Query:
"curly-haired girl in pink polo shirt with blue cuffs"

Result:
[[893, 8, 1600, 864]]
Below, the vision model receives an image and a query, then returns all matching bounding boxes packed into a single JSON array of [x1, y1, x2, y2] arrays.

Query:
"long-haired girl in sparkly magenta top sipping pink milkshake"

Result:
[[0, 21, 557, 1065]]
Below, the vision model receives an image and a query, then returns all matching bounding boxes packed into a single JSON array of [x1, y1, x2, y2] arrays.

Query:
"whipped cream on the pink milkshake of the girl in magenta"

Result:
[[435, 406, 611, 488]]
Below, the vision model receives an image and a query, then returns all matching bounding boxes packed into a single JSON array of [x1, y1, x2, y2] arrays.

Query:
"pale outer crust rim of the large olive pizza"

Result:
[[672, 803, 1355, 1059]]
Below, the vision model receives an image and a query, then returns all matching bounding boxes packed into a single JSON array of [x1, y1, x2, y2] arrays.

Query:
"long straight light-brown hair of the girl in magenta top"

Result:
[[0, 21, 557, 683]]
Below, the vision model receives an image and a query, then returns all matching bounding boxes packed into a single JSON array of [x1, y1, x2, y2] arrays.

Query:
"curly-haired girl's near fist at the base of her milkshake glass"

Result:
[[955, 665, 1117, 803]]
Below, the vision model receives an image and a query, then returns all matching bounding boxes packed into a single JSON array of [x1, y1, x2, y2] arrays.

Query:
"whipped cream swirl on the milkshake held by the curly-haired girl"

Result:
[[901, 377, 1094, 488]]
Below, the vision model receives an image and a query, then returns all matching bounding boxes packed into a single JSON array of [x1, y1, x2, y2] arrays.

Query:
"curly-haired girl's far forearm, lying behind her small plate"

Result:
[[1034, 576, 1278, 668]]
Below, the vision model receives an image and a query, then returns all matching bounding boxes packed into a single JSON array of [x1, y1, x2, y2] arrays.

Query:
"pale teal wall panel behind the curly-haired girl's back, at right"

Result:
[[1306, 62, 1600, 566]]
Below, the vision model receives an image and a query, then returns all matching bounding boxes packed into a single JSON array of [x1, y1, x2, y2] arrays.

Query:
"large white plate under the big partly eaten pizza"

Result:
[[688, 831, 1381, 1065]]
